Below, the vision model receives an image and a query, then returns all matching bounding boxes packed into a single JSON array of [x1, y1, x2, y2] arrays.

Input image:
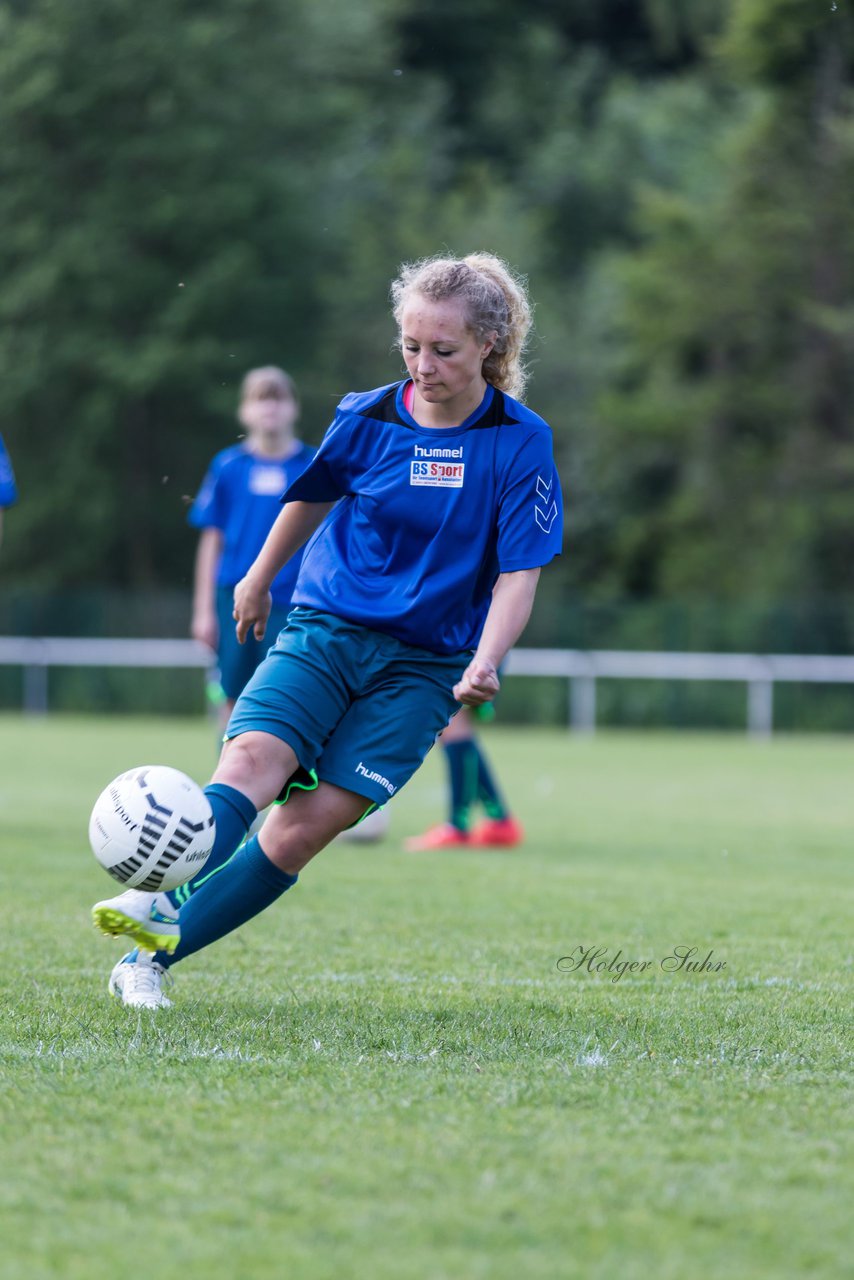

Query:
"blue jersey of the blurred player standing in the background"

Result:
[[188, 444, 314, 604]]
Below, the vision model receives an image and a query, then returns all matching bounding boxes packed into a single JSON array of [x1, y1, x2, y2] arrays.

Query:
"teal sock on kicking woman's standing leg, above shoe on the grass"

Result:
[[155, 836, 297, 969]]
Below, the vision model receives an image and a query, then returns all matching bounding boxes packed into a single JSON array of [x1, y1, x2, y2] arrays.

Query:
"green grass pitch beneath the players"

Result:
[[0, 716, 854, 1280]]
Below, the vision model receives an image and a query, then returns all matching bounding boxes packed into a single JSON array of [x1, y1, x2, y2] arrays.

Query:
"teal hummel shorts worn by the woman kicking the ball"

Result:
[[225, 605, 471, 805]]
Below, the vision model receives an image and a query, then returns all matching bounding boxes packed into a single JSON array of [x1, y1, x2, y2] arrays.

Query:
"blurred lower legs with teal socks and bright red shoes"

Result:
[[403, 704, 525, 852]]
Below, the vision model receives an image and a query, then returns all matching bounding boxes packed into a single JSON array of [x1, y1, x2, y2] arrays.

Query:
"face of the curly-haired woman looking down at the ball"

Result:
[[401, 294, 493, 421]]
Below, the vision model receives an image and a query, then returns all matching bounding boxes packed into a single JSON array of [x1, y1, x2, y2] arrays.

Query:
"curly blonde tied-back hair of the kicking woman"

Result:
[[391, 253, 533, 399]]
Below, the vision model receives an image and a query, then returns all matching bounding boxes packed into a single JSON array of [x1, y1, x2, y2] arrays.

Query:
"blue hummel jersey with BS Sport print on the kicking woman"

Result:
[[282, 381, 562, 653]]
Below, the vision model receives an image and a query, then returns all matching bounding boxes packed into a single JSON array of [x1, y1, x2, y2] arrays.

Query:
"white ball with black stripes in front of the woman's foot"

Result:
[[88, 764, 215, 893]]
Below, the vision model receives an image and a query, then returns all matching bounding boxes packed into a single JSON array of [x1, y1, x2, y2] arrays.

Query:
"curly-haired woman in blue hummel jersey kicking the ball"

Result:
[[95, 253, 561, 1007]]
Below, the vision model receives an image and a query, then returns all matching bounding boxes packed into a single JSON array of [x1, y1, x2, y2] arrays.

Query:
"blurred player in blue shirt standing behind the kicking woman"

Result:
[[189, 365, 314, 728]]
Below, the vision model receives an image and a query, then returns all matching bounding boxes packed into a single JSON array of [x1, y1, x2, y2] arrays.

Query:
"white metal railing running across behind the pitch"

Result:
[[0, 636, 854, 737]]
